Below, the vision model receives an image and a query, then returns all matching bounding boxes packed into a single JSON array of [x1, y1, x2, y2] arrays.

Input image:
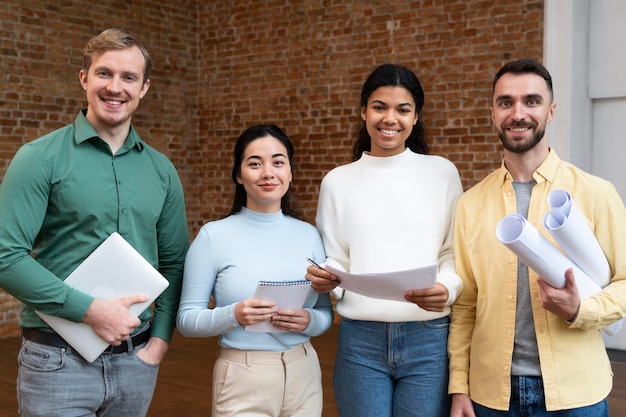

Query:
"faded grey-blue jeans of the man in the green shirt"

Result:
[[17, 340, 159, 417]]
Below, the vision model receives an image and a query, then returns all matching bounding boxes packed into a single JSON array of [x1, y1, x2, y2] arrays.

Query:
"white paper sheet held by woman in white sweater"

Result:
[[324, 265, 437, 302]]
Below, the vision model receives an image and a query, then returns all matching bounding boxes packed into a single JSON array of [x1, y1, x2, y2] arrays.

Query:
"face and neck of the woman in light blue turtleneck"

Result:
[[237, 136, 292, 213]]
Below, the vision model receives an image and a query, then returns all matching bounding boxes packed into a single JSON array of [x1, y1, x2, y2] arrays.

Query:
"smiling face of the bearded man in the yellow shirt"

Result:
[[491, 73, 556, 154]]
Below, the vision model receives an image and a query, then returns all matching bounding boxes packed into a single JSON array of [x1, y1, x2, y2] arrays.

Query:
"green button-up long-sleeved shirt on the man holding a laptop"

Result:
[[0, 110, 189, 341]]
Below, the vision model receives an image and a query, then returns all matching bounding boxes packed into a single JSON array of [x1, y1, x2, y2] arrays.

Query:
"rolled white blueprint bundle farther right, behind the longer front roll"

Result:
[[543, 190, 611, 288]]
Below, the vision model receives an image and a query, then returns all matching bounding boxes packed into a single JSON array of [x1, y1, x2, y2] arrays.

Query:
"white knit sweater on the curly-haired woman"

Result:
[[316, 149, 463, 322]]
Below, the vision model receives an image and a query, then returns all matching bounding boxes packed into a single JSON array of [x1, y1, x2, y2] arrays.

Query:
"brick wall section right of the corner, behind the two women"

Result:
[[198, 0, 543, 221]]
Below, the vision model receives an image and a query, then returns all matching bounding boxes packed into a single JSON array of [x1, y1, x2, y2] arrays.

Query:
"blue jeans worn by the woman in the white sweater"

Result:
[[334, 317, 450, 417]]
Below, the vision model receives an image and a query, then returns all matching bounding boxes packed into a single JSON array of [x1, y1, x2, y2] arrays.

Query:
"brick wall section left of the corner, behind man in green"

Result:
[[0, 0, 199, 335]]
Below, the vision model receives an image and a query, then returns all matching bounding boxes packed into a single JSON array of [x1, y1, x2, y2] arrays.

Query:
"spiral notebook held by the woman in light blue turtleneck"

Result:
[[244, 279, 311, 333]]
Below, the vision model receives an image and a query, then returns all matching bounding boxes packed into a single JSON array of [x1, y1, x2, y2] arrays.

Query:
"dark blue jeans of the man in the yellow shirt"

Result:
[[474, 376, 609, 417]]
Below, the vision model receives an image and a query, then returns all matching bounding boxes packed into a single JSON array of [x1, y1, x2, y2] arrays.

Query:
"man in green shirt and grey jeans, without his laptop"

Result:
[[0, 29, 189, 417]]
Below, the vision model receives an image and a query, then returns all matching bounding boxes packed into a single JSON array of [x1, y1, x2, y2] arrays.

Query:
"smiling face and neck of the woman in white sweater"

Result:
[[361, 87, 418, 156]]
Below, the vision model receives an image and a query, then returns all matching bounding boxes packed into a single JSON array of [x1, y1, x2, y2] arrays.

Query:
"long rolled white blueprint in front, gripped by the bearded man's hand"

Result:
[[496, 214, 623, 335]]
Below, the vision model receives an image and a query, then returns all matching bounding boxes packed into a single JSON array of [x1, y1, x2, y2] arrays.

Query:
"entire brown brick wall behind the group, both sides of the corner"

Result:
[[0, 0, 543, 335]]
